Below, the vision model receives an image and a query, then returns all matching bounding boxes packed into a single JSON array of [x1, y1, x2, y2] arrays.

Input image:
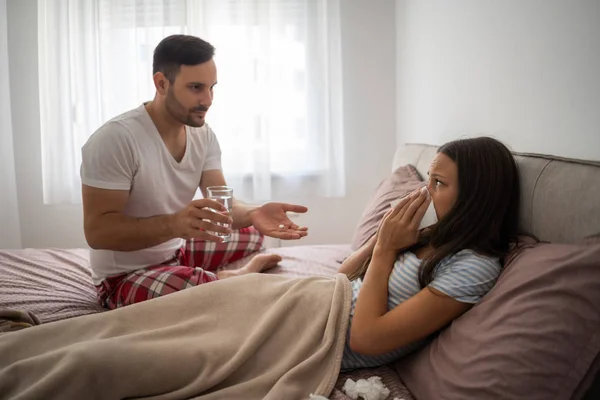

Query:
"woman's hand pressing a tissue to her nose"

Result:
[[374, 187, 431, 252]]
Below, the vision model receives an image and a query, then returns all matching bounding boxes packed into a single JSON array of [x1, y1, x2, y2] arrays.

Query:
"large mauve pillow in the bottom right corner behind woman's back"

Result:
[[396, 243, 600, 400]]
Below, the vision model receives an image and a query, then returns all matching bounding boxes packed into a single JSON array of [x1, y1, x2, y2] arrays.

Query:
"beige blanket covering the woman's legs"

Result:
[[0, 274, 351, 400]]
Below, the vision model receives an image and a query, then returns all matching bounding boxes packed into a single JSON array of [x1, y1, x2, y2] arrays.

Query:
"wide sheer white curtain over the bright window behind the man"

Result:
[[38, 0, 345, 204]]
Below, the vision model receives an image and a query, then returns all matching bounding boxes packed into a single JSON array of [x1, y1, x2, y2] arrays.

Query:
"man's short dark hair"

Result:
[[152, 35, 215, 83]]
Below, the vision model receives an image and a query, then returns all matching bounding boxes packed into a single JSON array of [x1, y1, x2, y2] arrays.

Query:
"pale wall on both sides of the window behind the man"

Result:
[[7, 0, 396, 247]]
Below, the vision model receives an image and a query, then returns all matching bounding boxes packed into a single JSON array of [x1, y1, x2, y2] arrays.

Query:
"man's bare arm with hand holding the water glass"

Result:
[[82, 185, 230, 251]]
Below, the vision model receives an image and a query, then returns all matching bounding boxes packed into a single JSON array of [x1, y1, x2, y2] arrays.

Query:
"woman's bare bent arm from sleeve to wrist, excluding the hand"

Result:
[[350, 250, 472, 355]]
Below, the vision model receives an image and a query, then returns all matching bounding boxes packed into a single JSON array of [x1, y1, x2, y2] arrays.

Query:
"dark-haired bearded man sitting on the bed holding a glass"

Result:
[[81, 35, 307, 309]]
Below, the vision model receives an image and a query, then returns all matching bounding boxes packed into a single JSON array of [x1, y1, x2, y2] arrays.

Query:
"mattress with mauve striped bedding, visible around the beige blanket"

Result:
[[0, 245, 414, 400]]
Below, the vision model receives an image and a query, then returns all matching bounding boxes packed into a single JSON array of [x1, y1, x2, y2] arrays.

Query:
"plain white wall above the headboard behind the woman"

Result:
[[396, 0, 600, 160]]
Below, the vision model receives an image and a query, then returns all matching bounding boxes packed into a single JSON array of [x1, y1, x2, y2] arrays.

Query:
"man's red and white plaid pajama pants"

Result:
[[96, 227, 264, 310]]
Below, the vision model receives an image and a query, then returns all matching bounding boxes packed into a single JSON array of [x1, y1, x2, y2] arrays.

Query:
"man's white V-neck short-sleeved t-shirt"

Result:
[[81, 104, 221, 285]]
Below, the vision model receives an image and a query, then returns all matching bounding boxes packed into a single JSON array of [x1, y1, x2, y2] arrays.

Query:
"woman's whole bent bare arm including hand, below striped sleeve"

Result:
[[350, 191, 471, 355]]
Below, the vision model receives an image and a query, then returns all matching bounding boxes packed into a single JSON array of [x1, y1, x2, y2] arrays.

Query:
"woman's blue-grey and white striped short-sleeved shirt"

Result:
[[342, 250, 501, 370]]
